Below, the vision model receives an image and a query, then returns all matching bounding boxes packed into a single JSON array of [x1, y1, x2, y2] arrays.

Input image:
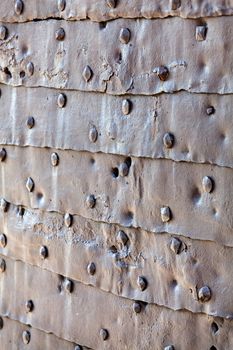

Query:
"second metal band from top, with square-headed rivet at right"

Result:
[[0, 17, 233, 94]]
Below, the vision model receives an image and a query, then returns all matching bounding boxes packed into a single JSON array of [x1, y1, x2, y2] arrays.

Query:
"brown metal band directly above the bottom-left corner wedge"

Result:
[[0, 254, 233, 350]]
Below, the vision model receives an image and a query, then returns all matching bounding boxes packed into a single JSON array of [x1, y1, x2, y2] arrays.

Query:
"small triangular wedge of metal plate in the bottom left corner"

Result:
[[0, 316, 87, 350]]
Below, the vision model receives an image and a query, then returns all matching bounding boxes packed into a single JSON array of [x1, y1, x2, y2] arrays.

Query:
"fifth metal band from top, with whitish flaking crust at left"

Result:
[[0, 205, 233, 317]]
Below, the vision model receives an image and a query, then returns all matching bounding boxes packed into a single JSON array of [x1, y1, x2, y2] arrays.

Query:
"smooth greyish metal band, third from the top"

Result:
[[0, 85, 233, 167]]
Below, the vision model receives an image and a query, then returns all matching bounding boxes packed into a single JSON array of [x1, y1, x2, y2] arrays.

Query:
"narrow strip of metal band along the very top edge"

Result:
[[0, 0, 233, 22]]
